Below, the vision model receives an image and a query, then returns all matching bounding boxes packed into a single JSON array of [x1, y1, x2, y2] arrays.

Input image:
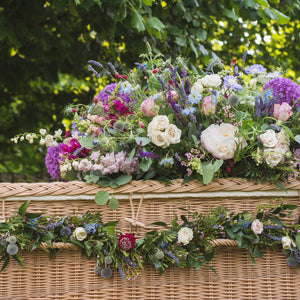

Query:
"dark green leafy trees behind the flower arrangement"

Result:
[[0, 0, 300, 180]]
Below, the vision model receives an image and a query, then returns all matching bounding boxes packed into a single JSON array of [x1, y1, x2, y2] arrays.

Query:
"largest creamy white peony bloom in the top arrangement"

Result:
[[201, 123, 247, 160]]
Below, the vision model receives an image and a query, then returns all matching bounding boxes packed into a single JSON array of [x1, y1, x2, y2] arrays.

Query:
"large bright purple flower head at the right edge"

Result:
[[263, 77, 300, 106]]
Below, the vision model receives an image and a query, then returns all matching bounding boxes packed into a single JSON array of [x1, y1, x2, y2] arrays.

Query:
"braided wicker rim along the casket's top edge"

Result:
[[0, 178, 300, 198]]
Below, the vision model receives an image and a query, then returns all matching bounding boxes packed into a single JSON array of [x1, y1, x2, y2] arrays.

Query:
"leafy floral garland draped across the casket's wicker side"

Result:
[[0, 199, 300, 280]]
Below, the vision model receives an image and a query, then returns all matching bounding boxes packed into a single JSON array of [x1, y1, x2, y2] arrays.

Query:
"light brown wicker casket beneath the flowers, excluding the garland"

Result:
[[0, 179, 300, 299]]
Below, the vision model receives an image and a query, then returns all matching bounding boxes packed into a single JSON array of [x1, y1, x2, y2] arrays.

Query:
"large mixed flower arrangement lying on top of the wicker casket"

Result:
[[13, 47, 300, 187]]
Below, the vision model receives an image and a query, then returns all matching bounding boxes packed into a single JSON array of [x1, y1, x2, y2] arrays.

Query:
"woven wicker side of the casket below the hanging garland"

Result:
[[0, 248, 300, 300]]
